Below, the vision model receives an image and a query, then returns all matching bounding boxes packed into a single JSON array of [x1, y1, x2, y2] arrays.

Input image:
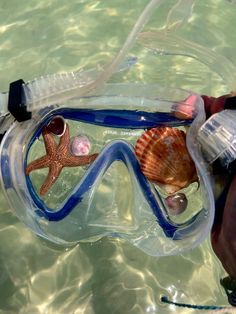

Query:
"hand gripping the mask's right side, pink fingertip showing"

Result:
[[174, 93, 236, 306]]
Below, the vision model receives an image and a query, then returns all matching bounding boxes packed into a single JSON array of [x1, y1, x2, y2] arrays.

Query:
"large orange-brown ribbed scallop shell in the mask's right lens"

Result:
[[135, 127, 198, 194]]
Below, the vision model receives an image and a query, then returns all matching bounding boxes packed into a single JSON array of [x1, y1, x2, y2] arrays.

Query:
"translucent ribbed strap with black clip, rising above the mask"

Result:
[[0, 0, 163, 132]]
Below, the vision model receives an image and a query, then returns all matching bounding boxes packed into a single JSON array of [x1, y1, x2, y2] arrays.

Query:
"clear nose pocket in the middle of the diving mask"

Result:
[[86, 161, 138, 234]]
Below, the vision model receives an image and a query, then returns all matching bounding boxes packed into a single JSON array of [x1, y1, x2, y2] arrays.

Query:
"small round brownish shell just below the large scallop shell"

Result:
[[165, 193, 188, 215]]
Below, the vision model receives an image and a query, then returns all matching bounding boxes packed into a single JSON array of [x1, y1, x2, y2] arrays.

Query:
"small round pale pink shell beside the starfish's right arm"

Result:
[[70, 135, 91, 156]]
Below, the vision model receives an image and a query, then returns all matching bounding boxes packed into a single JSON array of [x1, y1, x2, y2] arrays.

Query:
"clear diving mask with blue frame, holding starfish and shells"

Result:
[[1, 84, 214, 256]]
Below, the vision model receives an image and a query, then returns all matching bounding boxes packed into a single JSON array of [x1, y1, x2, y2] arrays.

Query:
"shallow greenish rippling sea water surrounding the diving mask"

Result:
[[0, 0, 236, 314]]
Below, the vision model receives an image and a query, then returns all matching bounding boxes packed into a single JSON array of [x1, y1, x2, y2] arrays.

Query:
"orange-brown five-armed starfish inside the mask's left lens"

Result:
[[25, 124, 98, 195]]
